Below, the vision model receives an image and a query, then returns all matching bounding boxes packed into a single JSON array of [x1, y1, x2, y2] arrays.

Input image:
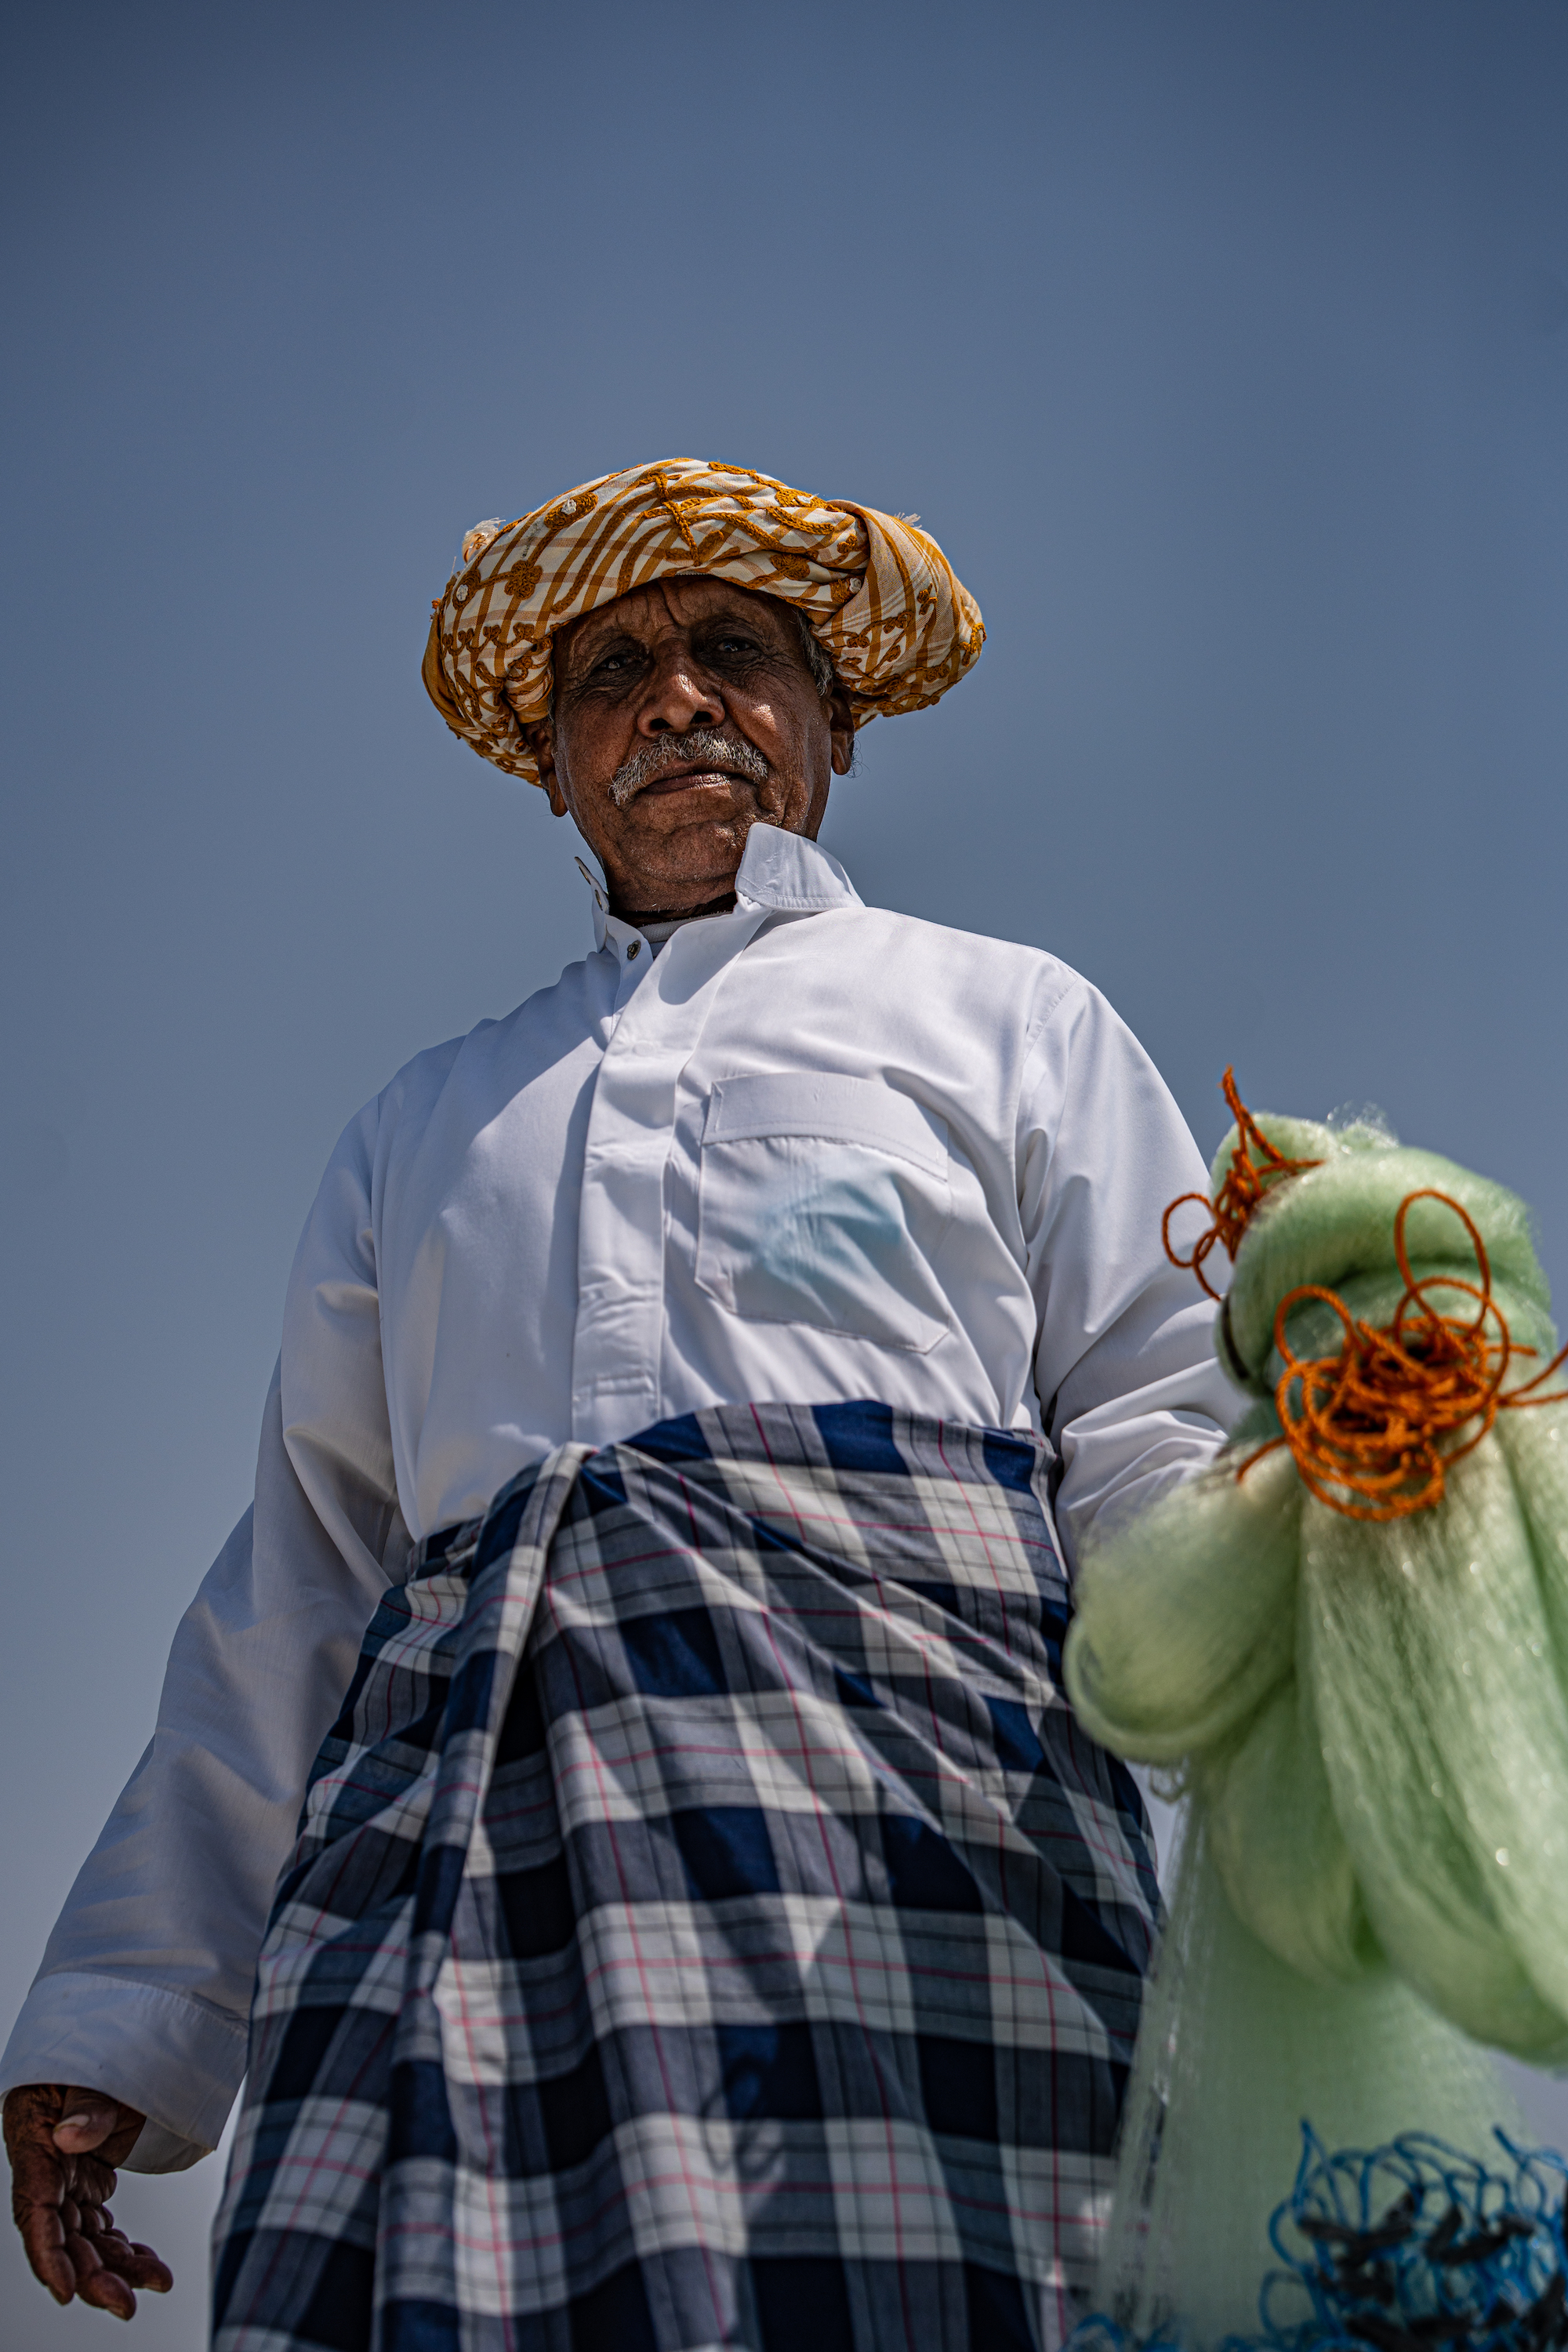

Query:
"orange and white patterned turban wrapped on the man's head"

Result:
[[426, 456, 985, 783]]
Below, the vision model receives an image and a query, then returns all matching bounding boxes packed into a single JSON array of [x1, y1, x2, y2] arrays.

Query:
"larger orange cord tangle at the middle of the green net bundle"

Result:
[[1236, 1185, 1568, 1519]]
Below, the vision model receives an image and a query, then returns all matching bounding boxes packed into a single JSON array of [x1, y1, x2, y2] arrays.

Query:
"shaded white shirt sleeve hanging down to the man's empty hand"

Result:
[[0, 1122, 407, 2171]]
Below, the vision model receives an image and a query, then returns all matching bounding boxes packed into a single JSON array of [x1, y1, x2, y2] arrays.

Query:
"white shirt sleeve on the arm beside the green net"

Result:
[[1018, 978, 1239, 1557]]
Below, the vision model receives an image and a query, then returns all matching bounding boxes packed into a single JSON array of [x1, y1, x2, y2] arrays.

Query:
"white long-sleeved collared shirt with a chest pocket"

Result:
[[0, 826, 1236, 2171]]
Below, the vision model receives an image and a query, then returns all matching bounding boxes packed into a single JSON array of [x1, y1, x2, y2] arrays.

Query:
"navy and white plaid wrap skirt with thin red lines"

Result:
[[214, 1404, 1156, 2352]]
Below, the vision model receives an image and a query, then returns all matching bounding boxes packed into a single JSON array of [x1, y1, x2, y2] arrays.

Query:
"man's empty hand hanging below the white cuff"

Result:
[[5, 2082, 174, 2319]]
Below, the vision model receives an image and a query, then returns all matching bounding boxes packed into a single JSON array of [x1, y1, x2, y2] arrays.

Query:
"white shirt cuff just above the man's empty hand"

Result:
[[0, 1969, 247, 2173]]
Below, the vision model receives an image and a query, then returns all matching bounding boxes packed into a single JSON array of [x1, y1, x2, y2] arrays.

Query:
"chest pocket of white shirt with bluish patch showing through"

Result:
[[696, 1073, 952, 1355]]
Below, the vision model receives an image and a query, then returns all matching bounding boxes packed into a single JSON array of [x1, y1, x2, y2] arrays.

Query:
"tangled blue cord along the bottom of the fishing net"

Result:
[[1067, 2131, 1568, 2352]]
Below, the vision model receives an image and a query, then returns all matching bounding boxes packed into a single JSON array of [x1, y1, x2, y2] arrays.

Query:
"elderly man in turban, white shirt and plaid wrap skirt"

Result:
[[2, 461, 1227, 2352]]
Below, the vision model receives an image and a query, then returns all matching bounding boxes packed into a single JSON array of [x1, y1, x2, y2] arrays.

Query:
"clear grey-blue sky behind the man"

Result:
[[0, 0, 1568, 2352]]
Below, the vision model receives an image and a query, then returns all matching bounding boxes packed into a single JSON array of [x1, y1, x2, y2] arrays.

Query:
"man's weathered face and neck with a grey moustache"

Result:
[[527, 576, 853, 917]]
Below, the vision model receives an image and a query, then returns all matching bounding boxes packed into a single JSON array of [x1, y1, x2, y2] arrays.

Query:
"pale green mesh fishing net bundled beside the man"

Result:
[[1065, 1096, 1568, 2347]]
